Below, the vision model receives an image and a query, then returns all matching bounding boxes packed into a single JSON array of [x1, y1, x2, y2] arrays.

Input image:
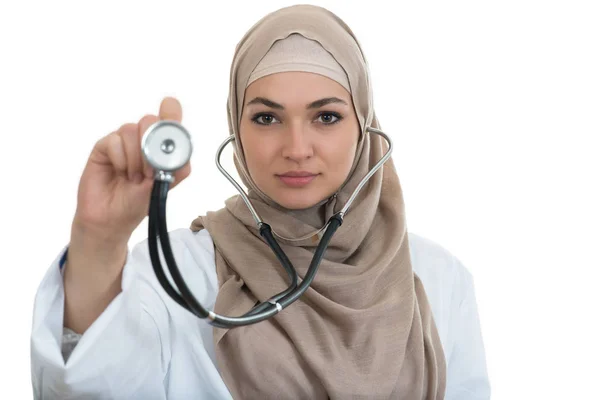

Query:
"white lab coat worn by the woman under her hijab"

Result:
[[31, 229, 490, 400]]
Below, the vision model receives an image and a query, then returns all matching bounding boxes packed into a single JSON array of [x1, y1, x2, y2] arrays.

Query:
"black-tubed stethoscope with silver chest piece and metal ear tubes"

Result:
[[142, 120, 393, 329]]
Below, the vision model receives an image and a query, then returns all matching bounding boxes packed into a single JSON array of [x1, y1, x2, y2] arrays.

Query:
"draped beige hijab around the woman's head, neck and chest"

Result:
[[191, 5, 446, 400]]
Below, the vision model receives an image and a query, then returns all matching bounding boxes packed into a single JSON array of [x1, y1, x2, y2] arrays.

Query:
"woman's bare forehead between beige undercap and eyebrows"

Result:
[[244, 71, 351, 104]]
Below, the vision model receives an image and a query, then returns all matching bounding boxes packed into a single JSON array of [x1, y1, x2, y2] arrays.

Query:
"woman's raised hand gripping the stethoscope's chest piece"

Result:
[[72, 97, 191, 247]]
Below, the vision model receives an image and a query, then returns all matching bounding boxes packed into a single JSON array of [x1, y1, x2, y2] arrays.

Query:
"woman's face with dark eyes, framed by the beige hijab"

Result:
[[240, 72, 359, 210]]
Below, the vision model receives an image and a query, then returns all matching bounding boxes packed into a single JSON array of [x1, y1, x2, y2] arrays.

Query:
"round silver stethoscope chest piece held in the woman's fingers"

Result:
[[142, 120, 193, 172]]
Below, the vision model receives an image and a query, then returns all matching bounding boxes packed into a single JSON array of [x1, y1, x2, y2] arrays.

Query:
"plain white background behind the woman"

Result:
[[0, 0, 600, 399]]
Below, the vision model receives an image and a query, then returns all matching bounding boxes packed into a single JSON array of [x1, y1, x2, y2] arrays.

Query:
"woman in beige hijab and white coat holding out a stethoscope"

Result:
[[32, 6, 489, 399]]
